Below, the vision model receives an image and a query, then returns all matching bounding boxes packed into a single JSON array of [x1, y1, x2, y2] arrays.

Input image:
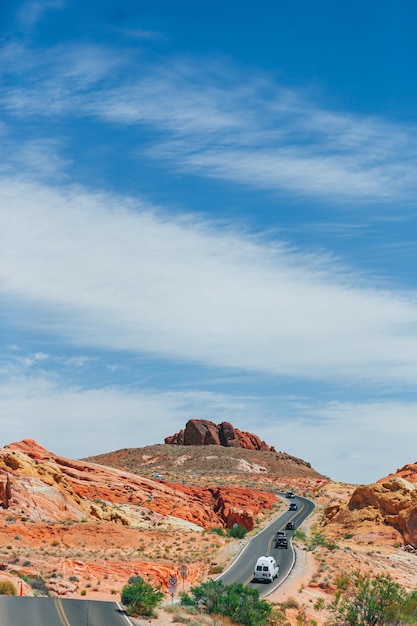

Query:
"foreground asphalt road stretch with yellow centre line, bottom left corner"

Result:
[[0, 596, 131, 626]]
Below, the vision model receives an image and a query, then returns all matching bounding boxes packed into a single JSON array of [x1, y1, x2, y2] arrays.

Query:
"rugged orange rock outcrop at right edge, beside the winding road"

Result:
[[325, 463, 417, 547]]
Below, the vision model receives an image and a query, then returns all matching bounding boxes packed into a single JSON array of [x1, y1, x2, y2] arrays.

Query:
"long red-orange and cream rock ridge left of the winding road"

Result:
[[0, 439, 276, 530]]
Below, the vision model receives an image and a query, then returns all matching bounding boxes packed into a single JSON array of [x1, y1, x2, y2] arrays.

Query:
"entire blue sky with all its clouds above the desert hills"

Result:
[[0, 0, 417, 483]]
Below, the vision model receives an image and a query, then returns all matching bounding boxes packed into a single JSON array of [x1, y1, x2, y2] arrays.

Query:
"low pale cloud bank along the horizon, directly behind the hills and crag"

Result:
[[0, 365, 417, 483]]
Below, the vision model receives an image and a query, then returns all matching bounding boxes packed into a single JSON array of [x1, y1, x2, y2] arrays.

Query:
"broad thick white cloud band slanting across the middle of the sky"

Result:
[[0, 176, 417, 385]]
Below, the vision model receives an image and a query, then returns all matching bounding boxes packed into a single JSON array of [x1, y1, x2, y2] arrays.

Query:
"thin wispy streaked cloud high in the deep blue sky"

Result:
[[2, 46, 417, 202]]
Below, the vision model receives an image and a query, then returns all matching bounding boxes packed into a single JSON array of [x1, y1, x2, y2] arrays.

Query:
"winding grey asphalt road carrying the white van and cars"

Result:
[[219, 494, 315, 596]]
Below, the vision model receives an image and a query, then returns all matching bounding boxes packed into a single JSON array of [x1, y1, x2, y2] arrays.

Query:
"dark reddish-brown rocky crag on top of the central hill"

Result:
[[165, 419, 275, 452]]
